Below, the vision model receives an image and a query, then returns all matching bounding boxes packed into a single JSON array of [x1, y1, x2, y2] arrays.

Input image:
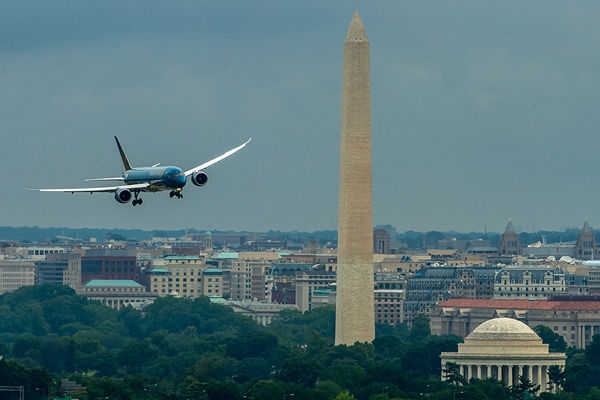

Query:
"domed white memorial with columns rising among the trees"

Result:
[[440, 318, 566, 391]]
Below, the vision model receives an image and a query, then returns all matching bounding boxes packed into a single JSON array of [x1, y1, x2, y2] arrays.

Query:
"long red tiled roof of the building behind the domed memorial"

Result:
[[439, 299, 600, 311]]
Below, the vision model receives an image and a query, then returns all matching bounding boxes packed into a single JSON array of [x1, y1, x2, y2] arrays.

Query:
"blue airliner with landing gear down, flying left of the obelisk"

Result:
[[29, 136, 252, 206]]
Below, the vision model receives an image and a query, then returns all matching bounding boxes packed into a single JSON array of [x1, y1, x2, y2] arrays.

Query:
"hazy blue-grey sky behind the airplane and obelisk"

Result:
[[0, 0, 600, 231]]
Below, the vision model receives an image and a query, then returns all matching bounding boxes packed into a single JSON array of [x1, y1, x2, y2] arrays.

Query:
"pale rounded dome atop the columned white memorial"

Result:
[[467, 318, 540, 341]]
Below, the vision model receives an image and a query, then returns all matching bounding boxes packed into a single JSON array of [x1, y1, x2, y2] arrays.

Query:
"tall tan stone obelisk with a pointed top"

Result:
[[335, 11, 375, 345]]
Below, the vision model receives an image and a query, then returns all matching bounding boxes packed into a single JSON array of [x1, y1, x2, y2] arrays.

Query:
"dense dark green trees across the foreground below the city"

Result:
[[0, 285, 600, 400]]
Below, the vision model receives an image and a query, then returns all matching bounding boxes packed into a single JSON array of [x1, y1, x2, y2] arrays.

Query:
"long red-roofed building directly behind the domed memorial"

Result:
[[430, 296, 600, 348]]
